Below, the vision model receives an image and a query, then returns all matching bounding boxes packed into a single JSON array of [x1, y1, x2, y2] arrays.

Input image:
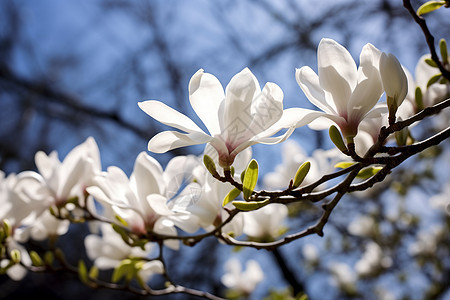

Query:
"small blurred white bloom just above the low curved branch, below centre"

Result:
[[244, 203, 288, 240]]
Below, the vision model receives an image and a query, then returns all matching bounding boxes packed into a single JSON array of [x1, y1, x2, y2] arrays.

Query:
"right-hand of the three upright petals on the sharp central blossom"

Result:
[[248, 82, 284, 135]]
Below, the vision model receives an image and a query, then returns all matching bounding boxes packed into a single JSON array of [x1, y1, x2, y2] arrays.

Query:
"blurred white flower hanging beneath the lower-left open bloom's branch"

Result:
[[84, 223, 164, 281]]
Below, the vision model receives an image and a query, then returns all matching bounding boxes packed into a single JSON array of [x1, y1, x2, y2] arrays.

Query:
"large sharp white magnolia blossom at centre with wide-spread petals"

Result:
[[139, 68, 293, 168]]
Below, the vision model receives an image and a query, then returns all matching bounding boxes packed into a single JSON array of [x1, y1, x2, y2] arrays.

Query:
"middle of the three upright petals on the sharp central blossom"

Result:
[[221, 68, 260, 144]]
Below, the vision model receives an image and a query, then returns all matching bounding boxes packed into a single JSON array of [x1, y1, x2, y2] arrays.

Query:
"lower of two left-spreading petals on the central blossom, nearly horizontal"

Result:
[[148, 131, 213, 153]]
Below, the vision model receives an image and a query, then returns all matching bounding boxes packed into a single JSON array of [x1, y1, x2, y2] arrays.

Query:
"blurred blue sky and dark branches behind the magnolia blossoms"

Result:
[[0, 0, 450, 299]]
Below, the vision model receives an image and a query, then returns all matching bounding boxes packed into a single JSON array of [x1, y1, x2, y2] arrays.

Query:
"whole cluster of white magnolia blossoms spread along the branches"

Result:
[[0, 39, 449, 294]]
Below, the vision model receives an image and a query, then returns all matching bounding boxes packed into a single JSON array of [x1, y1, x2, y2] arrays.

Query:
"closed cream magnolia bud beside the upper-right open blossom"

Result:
[[380, 52, 408, 122]]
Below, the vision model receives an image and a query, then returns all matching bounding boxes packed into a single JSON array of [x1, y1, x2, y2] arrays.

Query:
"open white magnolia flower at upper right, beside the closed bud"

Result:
[[291, 39, 383, 139]]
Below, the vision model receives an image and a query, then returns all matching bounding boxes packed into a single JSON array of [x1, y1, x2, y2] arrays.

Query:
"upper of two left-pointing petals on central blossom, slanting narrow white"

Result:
[[138, 100, 203, 133]]
